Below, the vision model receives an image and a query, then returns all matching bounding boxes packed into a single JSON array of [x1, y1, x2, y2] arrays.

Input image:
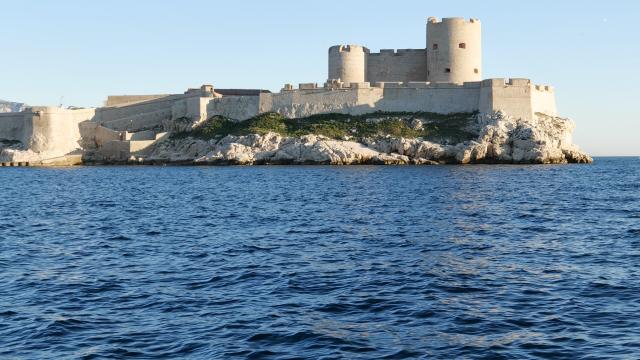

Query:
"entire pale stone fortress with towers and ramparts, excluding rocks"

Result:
[[0, 17, 557, 163]]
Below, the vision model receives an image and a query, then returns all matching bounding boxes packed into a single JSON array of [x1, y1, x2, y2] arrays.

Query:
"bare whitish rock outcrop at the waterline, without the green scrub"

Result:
[[142, 112, 592, 165]]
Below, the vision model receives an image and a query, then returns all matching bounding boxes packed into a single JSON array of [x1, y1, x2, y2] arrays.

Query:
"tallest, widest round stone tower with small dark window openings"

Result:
[[427, 17, 482, 83]]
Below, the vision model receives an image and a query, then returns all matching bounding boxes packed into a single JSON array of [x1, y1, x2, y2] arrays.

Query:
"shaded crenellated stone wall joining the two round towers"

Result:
[[367, 49, 427, 83]]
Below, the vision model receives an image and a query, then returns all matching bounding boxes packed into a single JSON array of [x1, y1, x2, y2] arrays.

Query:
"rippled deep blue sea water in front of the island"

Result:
[[0, 158, 640, 359]]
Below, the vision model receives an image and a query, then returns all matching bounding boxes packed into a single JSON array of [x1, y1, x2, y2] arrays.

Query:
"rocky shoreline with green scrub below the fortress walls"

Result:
[[0, 112, 593, 166]]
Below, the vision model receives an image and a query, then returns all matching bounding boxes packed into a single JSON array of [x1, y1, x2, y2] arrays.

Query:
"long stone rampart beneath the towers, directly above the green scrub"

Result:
[[201, 79, 556, 120]]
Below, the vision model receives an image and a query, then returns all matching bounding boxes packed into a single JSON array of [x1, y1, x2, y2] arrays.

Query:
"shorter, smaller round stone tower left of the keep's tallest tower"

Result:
[[329, 45, 369, 83]]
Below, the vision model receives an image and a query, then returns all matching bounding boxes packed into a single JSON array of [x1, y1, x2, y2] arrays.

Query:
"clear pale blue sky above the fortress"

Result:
[[0, 0, 640, 156]]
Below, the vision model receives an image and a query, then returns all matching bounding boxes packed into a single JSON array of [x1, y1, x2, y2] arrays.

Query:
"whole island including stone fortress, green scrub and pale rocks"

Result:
[[0, 18, 592, 165]]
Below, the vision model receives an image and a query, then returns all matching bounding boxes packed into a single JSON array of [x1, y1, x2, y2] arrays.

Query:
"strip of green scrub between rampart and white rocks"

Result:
[[176, 112, 475, 142]]
